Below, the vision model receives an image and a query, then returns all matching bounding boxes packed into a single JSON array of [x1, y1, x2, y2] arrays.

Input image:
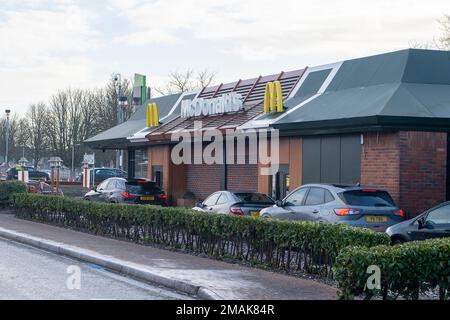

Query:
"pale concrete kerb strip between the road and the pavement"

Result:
[[0, 228, 223, 300]]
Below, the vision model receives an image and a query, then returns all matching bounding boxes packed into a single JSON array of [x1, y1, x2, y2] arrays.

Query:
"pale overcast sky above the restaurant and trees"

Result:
[[0, 0, 450, 113]]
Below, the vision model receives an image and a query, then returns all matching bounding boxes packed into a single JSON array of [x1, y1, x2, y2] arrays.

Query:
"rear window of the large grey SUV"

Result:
[[339, 190, 395, 207]]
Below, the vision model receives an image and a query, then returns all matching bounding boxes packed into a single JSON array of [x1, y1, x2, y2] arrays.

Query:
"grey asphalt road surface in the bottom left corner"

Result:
[[0, 238, 189, 300]]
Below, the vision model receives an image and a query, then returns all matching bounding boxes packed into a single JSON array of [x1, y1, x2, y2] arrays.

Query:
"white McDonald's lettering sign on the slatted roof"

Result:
[[181, 92, 243, 118]]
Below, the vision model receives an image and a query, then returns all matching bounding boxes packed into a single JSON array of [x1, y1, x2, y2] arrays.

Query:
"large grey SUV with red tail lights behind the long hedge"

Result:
[[261, 184, 405, 231]]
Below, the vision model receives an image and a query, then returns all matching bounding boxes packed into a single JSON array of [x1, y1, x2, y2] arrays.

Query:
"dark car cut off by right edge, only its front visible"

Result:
[[386, 201, 450, 244]]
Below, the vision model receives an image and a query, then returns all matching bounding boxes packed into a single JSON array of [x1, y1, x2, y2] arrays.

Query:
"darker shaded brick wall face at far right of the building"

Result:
[[399, 132, 447, 214]]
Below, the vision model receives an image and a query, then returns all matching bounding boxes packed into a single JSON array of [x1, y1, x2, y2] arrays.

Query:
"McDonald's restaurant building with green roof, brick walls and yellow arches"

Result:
[[85, 49, 450, 215]]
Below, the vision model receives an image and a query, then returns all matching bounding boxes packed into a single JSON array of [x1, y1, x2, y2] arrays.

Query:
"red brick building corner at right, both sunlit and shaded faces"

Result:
[[361, 131, 447, 215]]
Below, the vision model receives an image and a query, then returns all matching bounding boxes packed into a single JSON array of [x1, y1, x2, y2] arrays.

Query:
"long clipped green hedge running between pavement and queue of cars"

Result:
[[14, 194, 389, 277]]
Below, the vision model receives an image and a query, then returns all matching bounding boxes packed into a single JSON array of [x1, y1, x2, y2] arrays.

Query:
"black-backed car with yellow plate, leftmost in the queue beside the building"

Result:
[[83, 178, 167, 206]]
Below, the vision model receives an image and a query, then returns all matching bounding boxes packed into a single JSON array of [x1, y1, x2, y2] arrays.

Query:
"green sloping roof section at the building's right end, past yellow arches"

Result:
[[273, 49, 450, 134]]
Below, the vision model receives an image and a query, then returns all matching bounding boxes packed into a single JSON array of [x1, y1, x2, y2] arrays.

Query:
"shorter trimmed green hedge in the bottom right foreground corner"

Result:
[[334, 238, 450, 300]]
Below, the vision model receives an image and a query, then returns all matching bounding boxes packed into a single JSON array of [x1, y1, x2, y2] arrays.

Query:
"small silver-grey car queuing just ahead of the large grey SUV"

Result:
[[193, 191, 275, 217]]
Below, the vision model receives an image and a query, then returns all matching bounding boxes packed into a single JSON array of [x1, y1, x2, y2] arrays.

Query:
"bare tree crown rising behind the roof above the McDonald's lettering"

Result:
[[154, 69, 217, 95]]
